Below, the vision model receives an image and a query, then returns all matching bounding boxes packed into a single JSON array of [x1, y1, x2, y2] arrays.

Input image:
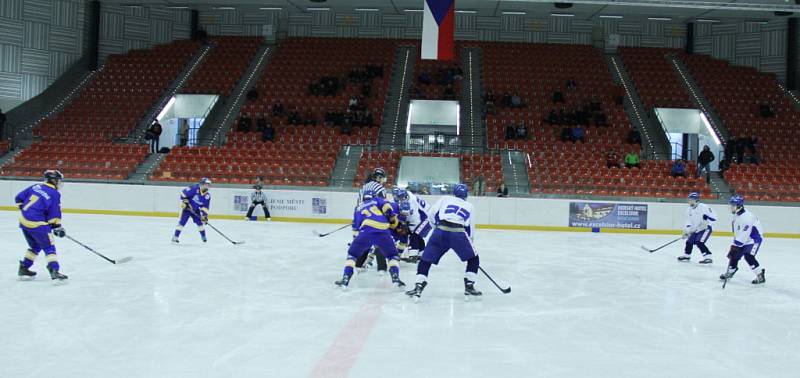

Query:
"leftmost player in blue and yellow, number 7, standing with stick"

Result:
[[15, 170, 67, 284]]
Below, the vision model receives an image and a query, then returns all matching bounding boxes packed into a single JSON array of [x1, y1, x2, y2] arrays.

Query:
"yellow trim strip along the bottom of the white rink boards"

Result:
[[0, 206, 800, 239]]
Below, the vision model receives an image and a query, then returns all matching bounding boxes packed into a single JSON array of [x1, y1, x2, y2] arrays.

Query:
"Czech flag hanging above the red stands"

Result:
[[422, 0, 456, 60]]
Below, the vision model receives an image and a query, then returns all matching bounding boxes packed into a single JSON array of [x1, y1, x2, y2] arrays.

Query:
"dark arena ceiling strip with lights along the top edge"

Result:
[[103, 0, 800, 22]]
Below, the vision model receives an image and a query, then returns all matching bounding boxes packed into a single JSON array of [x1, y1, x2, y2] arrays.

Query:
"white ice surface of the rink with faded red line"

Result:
[[0, 212, 800, 378]]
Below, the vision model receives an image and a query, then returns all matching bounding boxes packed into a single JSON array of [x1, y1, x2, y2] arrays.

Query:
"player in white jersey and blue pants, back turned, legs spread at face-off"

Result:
[[406, 184, 482, 301]]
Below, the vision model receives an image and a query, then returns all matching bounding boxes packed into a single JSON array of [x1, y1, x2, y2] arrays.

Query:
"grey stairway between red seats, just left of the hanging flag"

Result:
[[379, 44, 417, 149]]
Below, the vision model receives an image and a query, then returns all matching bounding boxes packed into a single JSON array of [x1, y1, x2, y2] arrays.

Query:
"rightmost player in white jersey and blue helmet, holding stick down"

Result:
[[719, 195, 766, 285]]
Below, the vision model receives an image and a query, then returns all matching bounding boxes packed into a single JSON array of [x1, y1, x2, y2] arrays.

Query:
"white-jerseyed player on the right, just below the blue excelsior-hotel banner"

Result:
[[678, 192, 717, 264]]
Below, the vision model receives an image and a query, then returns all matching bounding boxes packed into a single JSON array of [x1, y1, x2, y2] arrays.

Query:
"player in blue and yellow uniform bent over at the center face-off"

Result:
[[336, 189, 405, 289]]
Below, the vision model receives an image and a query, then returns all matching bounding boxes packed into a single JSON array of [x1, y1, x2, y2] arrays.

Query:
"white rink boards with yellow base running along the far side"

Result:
[[0, 180, 800, 238]]
